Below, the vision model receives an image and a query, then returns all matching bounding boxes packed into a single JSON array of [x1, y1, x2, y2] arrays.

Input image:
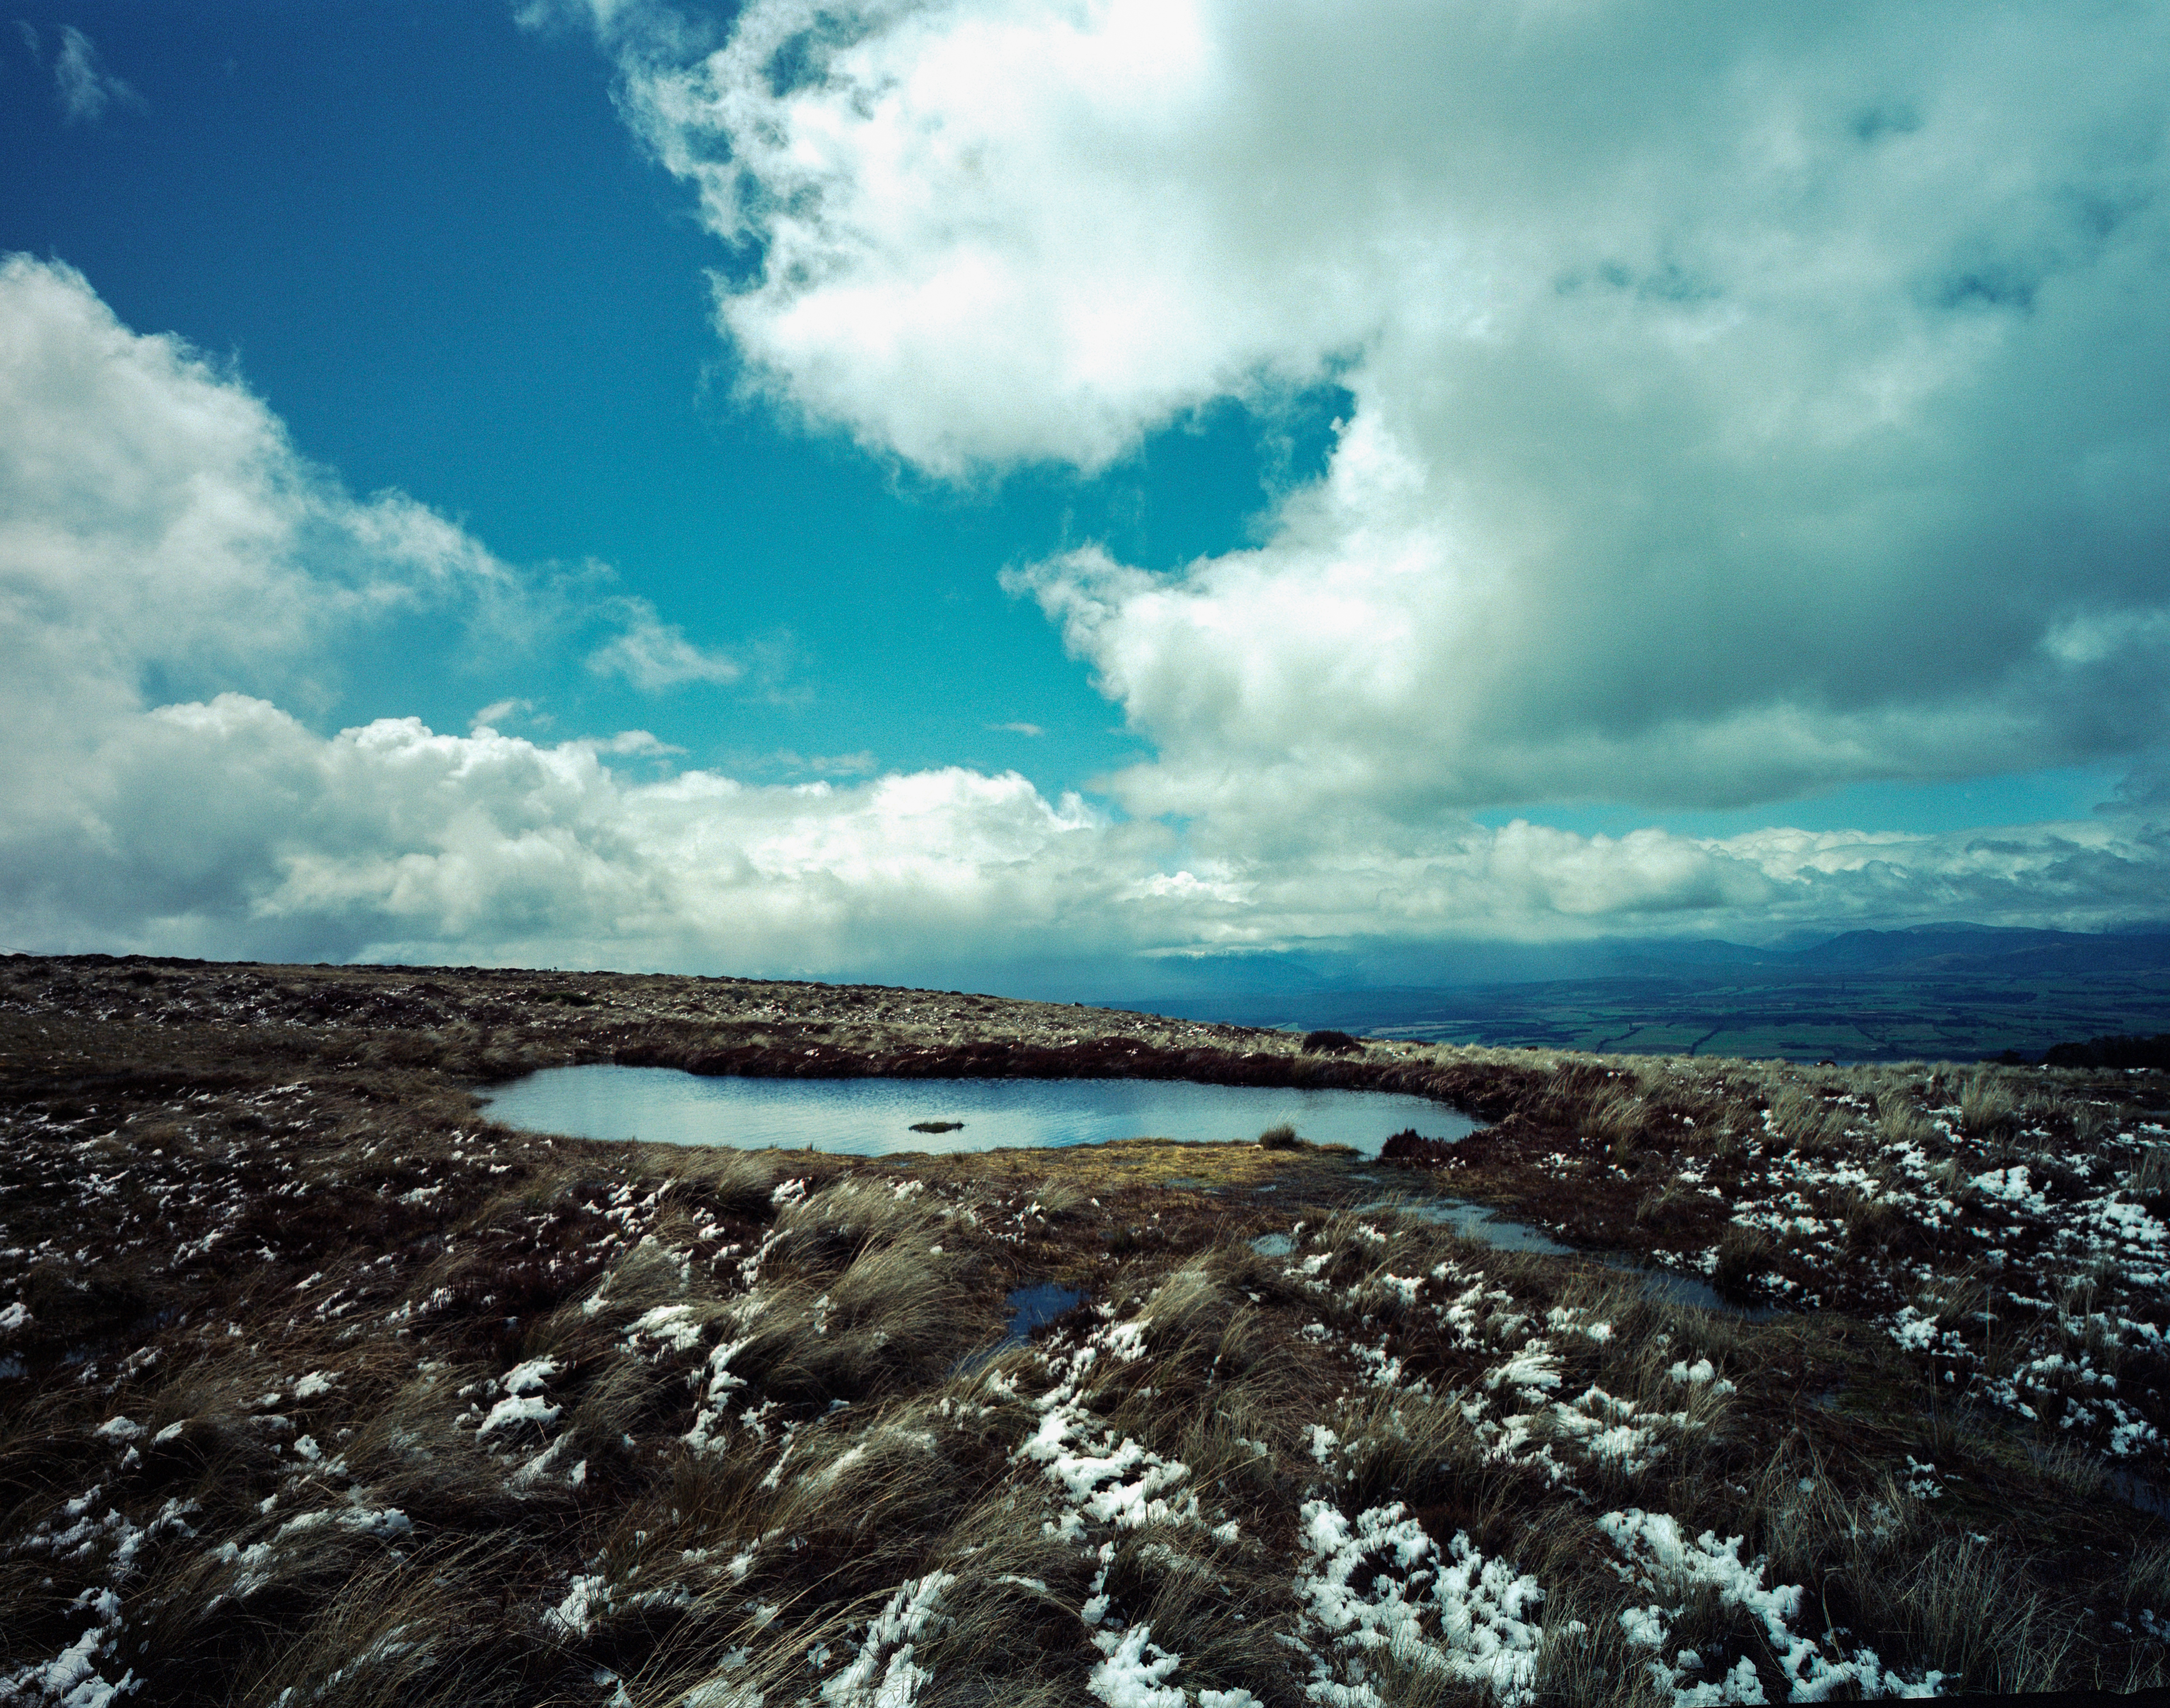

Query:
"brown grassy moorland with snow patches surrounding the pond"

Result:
[[0, 957, 2170, 1708]]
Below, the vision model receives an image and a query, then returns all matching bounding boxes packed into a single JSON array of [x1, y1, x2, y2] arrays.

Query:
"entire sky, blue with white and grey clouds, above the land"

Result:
[[0, 0, 2170, 996]]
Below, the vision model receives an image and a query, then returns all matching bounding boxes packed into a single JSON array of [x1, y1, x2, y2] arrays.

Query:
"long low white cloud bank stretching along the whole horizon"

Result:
[[21, 694, 2170, 977]]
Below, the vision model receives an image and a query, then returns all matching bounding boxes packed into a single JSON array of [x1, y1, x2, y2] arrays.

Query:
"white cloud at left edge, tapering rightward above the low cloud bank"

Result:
[[0, 256, 523, 777]]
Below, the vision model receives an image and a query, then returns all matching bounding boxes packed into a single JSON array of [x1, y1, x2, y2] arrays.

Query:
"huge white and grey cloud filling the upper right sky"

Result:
[[605, 0, 2170, 823]]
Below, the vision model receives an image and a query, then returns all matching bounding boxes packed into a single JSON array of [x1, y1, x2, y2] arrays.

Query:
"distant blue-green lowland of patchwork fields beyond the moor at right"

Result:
[[1163, 972, 2170, 1061]]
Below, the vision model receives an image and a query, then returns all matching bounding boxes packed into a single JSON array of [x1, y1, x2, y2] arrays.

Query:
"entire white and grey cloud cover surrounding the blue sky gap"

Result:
[[0, 0, 2170, 977]]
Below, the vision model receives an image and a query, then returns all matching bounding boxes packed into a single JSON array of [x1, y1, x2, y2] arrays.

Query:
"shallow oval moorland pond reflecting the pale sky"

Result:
[[482, 1066, 1475, 1157]]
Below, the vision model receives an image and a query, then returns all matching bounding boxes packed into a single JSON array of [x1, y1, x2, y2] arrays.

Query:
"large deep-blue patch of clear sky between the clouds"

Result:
[[0, 4, 1302, 788]]
